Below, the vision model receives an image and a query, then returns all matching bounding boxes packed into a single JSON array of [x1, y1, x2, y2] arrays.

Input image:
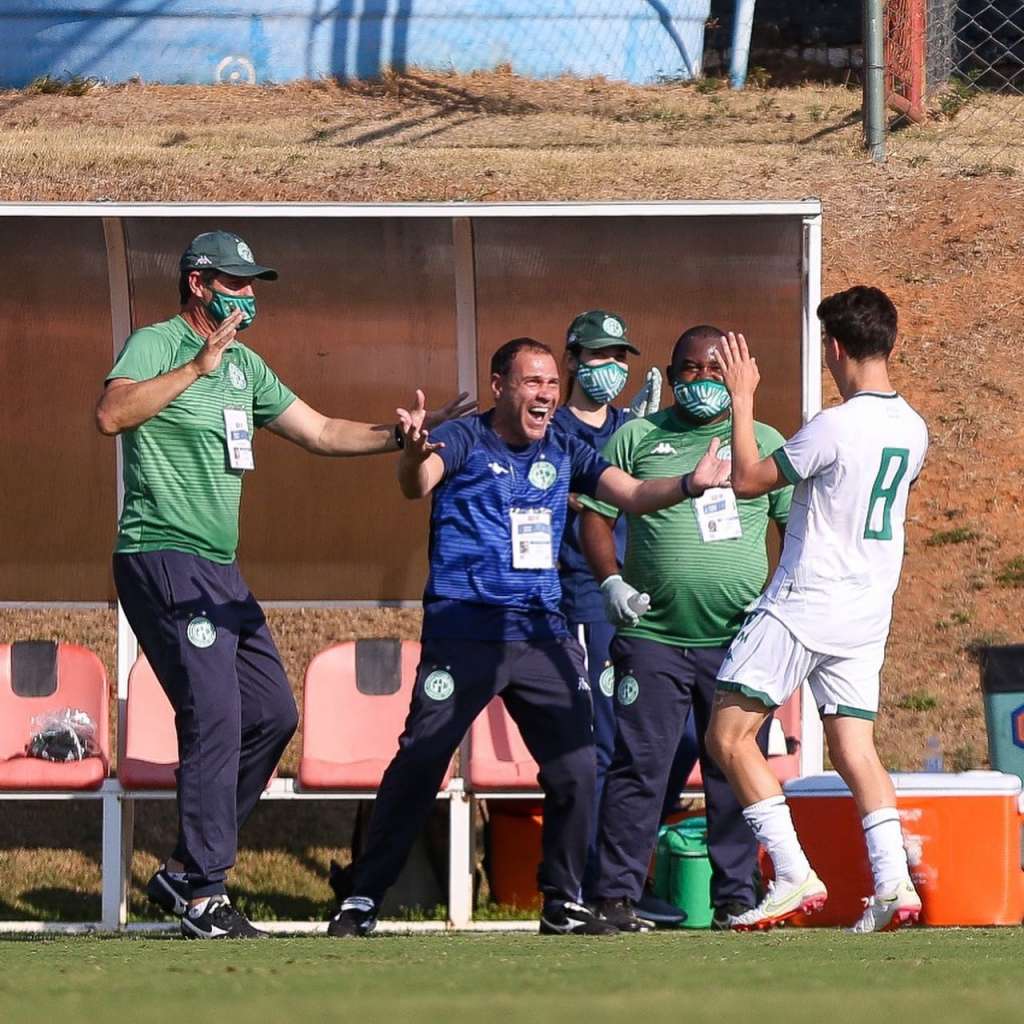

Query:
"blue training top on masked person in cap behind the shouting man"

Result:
[[552, 406, 633, 624]]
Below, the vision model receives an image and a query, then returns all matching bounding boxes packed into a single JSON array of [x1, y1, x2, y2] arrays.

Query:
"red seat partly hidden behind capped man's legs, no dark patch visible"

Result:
[[118, 654, 178, 790]]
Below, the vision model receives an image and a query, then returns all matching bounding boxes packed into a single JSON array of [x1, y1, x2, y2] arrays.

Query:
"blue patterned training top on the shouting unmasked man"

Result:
[[423, 411, 608, 642]]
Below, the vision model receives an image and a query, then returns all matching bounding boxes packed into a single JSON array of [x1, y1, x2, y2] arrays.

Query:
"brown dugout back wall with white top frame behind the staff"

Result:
[[0, 201, 820, 603]]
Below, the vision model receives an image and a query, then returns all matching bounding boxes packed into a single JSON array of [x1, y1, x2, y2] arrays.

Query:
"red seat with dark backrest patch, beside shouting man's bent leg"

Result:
[[299, 640, 452, 791]]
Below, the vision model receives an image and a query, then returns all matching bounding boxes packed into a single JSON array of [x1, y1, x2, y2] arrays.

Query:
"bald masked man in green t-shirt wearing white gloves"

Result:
[[581, 326, 793, 931]]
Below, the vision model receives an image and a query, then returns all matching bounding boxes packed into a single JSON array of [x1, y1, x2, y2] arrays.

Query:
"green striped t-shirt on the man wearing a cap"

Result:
[[106, 316, 295, 565]]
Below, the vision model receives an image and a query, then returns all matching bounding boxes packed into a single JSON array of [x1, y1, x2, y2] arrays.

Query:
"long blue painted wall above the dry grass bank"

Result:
[[0, 0, 711, 87]]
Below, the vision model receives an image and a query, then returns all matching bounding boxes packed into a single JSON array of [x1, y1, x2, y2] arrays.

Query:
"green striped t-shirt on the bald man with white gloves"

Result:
[[580, 408, 793, 647]]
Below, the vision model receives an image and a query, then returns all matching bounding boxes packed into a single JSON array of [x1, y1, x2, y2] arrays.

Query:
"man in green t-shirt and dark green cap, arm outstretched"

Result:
[[96, 231, 472, 938]]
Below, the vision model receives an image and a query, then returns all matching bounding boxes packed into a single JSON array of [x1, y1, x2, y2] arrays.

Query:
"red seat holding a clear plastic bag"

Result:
[[0, 641, 111, 791]]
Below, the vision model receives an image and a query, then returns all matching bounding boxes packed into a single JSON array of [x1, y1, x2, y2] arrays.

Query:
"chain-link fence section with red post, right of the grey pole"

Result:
[[886, 0, 1024, 173]]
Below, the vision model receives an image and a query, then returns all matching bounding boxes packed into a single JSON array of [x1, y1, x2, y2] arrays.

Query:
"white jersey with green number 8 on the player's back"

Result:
[[757, 391, 928, 656]]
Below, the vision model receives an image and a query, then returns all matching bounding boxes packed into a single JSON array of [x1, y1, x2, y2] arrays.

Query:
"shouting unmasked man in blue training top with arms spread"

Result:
[[328, 338, 729, 937]]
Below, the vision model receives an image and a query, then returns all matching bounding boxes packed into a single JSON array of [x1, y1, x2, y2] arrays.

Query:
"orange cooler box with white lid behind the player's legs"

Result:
[[785, 771, 1024, 927]]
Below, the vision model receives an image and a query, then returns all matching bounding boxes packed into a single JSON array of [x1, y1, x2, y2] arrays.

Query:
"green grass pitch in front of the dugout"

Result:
[[0, 929, 1021, 1024]]
